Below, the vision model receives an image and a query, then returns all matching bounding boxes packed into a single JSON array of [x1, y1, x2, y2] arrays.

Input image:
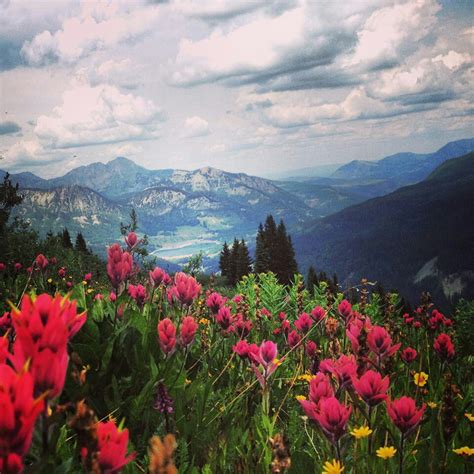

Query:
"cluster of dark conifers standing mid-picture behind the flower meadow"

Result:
[[219, 215, 298, 285]]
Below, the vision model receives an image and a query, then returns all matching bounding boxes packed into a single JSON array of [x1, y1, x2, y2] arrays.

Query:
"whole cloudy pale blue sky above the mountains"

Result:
[[0, 0, 474, 177]]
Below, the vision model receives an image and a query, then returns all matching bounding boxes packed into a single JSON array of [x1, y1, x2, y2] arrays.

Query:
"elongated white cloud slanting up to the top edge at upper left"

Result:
[[21, 2, 160, 66]]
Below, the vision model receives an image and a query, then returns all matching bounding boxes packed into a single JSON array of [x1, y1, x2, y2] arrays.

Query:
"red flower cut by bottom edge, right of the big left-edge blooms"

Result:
[[96, 421, 136, 473]]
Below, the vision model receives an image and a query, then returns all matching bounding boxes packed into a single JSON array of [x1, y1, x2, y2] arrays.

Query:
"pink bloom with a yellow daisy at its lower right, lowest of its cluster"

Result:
[[312, 397, 352, 444]]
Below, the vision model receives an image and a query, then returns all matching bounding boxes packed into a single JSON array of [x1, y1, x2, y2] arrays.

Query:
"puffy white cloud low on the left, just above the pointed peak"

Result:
[[34, 84, 165, 148]]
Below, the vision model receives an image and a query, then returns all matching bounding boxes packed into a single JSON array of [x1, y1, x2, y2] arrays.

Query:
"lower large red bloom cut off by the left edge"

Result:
[[0, 363, 44, 462]]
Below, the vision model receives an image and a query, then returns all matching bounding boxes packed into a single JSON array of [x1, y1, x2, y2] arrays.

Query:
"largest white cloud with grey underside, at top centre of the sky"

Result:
[[171, 2, 373, 89]]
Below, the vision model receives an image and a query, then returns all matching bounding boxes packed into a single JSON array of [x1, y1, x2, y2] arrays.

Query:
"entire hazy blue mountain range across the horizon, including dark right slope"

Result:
[[0, 139, 474, 304]]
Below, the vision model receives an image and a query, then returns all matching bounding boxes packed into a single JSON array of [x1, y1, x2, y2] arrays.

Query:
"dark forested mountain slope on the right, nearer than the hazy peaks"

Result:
[[293, 152, 474, 303]]
